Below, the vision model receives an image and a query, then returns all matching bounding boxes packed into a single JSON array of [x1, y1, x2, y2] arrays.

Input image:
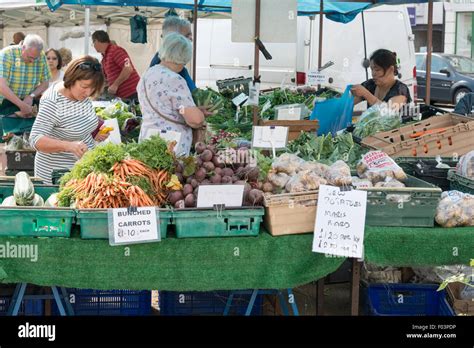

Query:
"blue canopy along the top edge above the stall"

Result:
[[46, 0, 372, 23]]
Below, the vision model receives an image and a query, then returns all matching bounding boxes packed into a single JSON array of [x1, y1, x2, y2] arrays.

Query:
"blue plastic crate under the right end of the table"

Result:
[[365, 284, 455, 316]]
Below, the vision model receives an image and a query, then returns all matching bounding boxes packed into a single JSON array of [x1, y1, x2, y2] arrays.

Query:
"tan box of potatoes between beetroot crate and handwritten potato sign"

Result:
[[263, 191, 318, 236]]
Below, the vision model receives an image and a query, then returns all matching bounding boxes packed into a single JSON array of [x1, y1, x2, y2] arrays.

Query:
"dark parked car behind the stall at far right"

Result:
[[416, 53, 474, 104]]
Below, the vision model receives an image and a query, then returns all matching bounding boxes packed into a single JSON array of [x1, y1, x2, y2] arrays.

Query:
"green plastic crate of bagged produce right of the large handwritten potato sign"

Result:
[[365, 175, 442, 227]]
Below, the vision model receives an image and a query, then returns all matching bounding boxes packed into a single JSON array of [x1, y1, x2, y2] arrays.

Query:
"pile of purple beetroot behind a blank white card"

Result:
[[168, 143, 263, 209]]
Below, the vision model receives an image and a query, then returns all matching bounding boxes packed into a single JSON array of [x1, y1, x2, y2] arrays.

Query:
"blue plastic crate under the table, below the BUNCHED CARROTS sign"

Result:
[[52, 289, 151, 316]]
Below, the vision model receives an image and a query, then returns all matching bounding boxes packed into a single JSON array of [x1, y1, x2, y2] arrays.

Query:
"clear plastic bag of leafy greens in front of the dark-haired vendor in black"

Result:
[[353, 103, 402, 138]]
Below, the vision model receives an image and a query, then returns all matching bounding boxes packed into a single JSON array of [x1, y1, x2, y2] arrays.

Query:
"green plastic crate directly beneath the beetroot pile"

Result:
[[173, 208, 264, 238]]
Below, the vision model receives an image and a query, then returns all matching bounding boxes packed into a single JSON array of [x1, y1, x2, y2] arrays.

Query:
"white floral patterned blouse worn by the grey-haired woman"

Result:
[[137, 65, 196, 155]]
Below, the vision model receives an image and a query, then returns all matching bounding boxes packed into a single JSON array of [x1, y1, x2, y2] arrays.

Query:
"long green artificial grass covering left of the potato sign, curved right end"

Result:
[[0, 232, 344, 291]]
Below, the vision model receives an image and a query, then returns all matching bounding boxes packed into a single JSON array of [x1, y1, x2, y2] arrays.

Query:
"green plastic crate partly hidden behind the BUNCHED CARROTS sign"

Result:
[[76, 209, 172, 239]]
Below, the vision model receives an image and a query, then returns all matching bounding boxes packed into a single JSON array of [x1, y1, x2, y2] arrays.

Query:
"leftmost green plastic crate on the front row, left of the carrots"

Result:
[[0, 207, 76, 237]]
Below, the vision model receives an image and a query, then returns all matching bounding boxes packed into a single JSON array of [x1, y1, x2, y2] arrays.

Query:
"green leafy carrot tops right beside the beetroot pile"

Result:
[[124, 135, 174, 171]]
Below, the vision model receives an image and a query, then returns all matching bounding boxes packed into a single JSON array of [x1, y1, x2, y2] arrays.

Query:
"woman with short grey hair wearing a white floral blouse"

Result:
[[137, 33, 205, 154]]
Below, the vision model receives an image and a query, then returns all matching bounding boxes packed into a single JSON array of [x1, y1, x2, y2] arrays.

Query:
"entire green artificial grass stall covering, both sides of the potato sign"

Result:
[[0, 227, 474, 291]]
